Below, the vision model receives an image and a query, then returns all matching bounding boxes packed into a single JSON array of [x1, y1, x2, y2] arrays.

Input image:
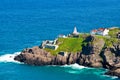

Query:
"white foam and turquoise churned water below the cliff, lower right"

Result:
[[62, 63, 118, 80]]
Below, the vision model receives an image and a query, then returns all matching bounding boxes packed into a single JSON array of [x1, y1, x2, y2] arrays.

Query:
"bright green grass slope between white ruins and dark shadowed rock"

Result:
[[45, 38, 84, 55]]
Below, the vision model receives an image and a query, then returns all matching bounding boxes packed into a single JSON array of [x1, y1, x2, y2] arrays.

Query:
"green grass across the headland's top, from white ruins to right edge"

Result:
[[45, 28, 120, 55]]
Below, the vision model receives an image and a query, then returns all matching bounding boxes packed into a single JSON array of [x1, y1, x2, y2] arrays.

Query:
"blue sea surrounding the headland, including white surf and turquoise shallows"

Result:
[[0, 0, 120, 80]]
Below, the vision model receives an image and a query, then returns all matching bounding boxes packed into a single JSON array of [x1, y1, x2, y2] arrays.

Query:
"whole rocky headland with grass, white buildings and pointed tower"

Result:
[[14, 27, 120, 77]]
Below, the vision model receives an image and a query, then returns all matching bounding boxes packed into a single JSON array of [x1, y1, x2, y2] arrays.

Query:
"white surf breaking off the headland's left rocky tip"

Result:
[[0, 52, 20, 63]]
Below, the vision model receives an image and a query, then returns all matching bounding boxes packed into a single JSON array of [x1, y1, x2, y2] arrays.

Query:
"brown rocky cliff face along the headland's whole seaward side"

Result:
[[14, 36, 120, 77]]
